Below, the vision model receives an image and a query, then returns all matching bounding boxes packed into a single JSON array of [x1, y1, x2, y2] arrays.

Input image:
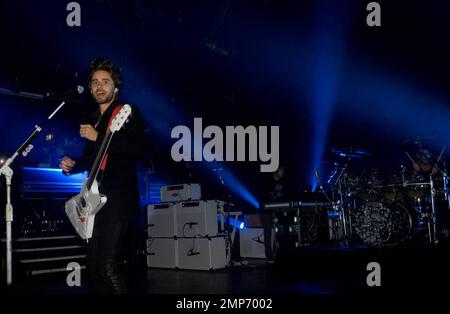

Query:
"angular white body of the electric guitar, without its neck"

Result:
[[65, 180, 107, 240]]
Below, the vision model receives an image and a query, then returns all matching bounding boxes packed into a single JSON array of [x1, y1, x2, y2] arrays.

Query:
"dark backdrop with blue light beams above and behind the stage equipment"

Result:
[[0, 0, 450, 211]]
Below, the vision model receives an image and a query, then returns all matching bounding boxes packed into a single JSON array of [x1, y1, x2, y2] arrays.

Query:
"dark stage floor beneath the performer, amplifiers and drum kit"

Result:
[[2, 246, 450, 296]]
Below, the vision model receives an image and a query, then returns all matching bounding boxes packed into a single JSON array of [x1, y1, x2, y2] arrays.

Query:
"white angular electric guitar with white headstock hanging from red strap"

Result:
[[65, 105, 131, 240]]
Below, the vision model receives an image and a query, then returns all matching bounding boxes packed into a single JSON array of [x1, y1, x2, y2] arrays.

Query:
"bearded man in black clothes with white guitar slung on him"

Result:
[[60, 59, 144, 293]]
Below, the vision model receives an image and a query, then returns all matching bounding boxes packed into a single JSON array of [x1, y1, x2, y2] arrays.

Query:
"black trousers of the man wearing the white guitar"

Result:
[[87, 217, 129, 294]]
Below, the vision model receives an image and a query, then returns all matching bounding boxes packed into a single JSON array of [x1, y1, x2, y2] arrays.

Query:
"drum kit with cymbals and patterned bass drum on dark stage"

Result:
[[327, 139, 450, 247]]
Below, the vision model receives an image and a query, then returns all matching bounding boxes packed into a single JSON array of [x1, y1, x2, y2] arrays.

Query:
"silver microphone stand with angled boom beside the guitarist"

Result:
[[0, 101, 66, 286]]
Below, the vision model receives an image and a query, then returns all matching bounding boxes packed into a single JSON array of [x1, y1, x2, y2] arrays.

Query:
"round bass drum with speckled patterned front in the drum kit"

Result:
[[352, 201, 413, 247]]
